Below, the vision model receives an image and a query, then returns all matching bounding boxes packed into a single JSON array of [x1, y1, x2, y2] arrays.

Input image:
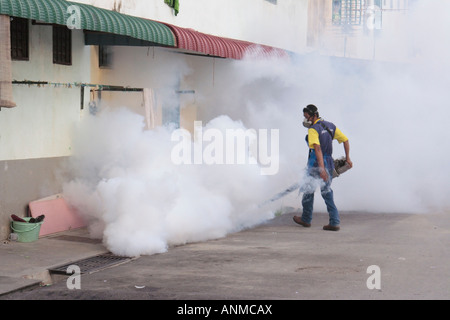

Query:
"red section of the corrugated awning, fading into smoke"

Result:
[[168, 24, 288, 59]]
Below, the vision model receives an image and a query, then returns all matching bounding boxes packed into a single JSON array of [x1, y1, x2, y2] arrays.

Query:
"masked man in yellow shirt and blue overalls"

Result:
[[294, 104, 353, 231]]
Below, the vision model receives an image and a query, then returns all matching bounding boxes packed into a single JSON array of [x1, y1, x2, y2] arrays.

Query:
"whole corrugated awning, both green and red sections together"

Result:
[[0, 0, 289, 59]]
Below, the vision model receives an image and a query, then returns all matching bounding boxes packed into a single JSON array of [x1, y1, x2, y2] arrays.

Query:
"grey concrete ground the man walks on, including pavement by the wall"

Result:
[[0, 212, 450, 300]]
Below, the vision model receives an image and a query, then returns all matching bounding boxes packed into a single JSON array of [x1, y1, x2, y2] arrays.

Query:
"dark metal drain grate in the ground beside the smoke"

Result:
[[48, 252, 131, 275]]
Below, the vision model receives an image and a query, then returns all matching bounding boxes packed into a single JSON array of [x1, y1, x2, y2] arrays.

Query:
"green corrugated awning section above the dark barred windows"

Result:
[[0, 0, 176, 47]]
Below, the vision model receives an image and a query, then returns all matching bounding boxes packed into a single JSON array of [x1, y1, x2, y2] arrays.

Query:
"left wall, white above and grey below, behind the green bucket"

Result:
[[0, 21, 90, 239]]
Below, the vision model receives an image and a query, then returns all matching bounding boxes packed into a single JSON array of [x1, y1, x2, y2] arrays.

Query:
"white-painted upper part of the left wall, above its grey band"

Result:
[[0, 22, 90, 160]]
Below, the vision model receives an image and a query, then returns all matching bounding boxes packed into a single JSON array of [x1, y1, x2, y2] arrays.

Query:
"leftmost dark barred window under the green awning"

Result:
[[11, 17, 30, 61]]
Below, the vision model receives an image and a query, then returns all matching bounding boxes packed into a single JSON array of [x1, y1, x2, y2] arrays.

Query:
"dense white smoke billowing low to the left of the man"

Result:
[[64, 108, 273, 256]]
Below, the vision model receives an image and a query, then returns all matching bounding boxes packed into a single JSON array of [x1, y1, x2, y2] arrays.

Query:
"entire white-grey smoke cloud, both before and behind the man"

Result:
[[64, 1, 450, 256]]
